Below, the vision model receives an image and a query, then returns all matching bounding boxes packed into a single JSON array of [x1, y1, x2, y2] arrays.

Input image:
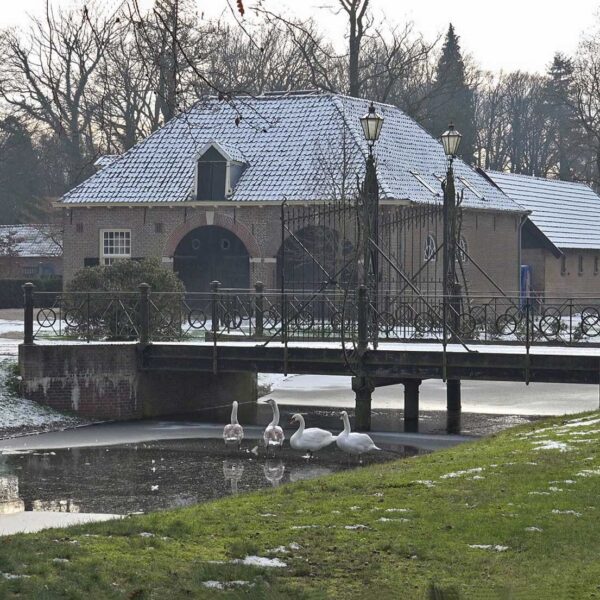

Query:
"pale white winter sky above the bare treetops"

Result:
[[0, 0, 600, 72]]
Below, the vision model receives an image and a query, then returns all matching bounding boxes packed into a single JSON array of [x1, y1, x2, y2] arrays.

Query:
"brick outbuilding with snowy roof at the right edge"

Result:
[[487, 172, 600, 299]]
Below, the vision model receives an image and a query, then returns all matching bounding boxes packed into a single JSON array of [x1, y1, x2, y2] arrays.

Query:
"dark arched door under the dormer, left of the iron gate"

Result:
[[173, 225, 250, 292]]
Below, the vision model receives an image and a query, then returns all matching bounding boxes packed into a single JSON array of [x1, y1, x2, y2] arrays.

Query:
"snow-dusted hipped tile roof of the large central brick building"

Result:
[[63, 93, 521, 211]]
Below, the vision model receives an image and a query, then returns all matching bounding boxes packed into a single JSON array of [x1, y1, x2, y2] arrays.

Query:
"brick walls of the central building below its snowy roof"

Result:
[[64, 205, 519, 292]]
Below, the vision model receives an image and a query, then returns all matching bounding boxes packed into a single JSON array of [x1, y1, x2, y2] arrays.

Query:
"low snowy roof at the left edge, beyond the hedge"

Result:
[[0, 225, 62, 258]]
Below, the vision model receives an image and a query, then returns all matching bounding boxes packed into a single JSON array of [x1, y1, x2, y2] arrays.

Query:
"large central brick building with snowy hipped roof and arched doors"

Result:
[[59, 92, 525, 292]]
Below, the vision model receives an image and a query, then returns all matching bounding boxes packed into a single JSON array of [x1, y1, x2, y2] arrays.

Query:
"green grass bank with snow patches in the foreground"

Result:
[[0, 413, 600, 600]]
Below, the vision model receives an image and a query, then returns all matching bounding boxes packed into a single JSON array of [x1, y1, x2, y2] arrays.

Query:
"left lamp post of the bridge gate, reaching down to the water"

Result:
[[352, 102, 383, 431]]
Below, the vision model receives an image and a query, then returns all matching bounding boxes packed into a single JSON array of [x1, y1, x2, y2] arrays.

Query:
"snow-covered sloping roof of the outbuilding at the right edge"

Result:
[[487, 171, 600, 249]]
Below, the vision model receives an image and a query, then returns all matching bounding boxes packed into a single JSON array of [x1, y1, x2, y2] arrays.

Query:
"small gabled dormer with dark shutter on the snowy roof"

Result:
[[196, 142, 248, 201]]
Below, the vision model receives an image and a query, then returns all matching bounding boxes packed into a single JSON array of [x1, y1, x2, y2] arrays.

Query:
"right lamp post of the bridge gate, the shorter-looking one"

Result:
[[441, 123, 462, 341]]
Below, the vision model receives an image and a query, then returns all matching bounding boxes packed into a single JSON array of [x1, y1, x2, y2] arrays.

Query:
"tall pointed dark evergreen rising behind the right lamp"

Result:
[[427, 23, 475, 163]]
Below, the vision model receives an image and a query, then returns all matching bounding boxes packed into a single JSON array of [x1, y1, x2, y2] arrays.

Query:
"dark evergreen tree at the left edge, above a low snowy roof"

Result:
[[0, 116, 42, 224]]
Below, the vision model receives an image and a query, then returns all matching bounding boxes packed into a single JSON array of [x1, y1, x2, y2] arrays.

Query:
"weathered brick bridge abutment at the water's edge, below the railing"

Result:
[[19, 344, 256, 420]]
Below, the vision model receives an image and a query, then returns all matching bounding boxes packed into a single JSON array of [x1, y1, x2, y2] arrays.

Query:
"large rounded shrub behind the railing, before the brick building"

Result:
[[63, 258, 185, 340]]
